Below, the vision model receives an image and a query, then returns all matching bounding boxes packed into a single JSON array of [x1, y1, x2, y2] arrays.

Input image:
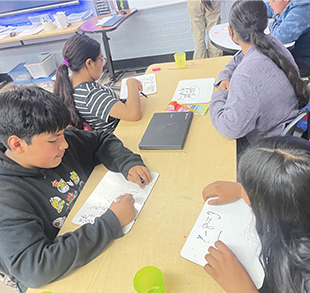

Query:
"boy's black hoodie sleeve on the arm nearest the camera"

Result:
[[0, 186, 123, 288]]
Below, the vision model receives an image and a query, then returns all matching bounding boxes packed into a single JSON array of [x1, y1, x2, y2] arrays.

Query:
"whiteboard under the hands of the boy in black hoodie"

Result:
[[72, 171, 159, 234]]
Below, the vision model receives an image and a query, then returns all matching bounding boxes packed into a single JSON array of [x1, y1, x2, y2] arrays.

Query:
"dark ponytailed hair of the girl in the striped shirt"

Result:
[[54, 34, 100, 129]]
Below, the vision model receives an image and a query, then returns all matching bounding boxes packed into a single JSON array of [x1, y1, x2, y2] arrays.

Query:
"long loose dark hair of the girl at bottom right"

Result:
[[238, 136, 310, 293]]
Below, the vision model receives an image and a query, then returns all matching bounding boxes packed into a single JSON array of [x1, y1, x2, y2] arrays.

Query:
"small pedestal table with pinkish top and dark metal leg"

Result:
[[81, 9, 138, 84]]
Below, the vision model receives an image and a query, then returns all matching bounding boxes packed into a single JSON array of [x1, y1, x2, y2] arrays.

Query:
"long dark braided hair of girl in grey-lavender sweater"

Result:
[[229, 0, 309, 109]]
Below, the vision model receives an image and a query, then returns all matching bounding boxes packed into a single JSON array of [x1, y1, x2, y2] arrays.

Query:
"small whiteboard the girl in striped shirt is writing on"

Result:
[[120, 73, 157, 99]]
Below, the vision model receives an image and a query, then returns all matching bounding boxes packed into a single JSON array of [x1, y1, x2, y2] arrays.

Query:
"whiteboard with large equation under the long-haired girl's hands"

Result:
[[181, 199, 264, 288]]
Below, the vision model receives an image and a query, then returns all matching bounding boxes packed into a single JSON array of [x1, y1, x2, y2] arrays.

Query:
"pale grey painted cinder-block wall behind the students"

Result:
[[0, 1, 233, 73]]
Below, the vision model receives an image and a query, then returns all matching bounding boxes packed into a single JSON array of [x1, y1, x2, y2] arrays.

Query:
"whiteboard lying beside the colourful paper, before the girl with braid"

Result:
[[172, 77, 215, 104]]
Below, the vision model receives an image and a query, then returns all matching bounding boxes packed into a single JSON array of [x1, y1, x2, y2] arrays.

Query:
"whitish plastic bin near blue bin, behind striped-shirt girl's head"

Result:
[[25, 53, 56, 79]]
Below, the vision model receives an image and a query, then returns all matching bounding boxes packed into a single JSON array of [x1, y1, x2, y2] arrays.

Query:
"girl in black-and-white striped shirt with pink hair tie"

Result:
[[54, 34, 142, 132]]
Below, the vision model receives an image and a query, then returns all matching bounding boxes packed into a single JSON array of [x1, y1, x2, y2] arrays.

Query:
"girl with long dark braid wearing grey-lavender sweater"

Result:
[[209, 0, 309, 151]]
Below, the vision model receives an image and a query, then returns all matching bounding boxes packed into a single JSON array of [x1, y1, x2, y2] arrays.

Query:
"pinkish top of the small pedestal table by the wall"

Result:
[[81, 9, 138, 33]]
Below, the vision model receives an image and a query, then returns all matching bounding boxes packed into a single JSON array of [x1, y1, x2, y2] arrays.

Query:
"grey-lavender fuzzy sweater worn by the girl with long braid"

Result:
[[210, 36, 299, 144]]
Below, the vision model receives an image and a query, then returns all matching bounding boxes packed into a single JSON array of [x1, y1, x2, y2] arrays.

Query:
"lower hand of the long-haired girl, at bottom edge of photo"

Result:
[[204, 241, 258, 293]]
